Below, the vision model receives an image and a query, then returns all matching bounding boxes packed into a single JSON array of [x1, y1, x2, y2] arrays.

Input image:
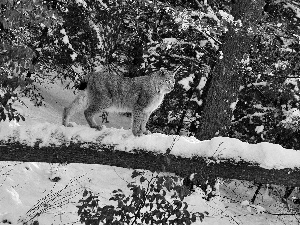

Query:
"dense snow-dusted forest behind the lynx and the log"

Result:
[[0, 0, 300, 149]]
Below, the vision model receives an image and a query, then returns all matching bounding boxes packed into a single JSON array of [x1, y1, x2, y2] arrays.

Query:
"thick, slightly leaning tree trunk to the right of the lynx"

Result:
[[196, 0, 264, 140]]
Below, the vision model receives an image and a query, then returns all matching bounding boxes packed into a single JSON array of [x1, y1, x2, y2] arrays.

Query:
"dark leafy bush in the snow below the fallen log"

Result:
[[77, 171, 206, 225]]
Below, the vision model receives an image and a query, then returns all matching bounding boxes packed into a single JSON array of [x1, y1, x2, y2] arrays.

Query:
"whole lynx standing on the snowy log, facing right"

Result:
[[63, 69, 175, 136]]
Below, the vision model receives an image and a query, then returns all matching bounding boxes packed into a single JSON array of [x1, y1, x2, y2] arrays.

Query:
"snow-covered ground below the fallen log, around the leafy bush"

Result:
[[0, 162, 293, 225]]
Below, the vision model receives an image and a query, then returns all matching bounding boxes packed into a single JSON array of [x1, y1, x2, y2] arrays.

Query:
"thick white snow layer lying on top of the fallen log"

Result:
[[0, 122, 300, 169]]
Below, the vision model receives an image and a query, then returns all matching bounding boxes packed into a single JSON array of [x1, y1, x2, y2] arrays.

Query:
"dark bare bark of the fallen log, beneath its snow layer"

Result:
[[0, 143, 300, 187]]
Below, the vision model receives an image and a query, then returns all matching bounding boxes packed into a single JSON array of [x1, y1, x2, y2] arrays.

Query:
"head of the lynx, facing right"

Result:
[[154, 69, 175, 93]]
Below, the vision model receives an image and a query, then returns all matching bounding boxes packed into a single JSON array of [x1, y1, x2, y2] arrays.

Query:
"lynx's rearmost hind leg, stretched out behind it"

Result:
[[62, 92, 87, 127]]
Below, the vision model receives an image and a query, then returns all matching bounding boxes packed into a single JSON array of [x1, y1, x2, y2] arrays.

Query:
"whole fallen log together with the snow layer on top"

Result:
[[0, 123, 300, 186]]
